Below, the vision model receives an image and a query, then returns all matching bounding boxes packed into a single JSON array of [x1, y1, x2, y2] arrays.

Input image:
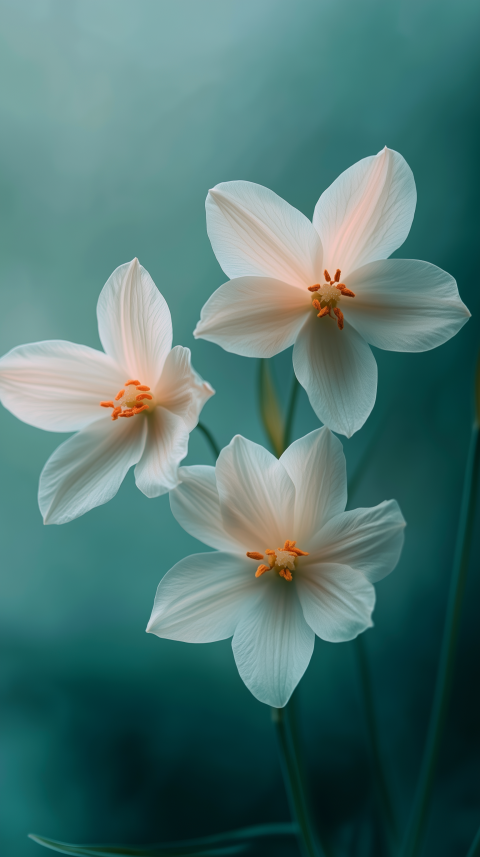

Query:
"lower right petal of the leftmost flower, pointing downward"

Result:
[[133, 406, 189, 497]]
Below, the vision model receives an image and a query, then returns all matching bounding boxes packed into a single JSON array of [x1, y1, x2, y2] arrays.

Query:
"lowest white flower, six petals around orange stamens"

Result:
[[147, 428, 405, 708]]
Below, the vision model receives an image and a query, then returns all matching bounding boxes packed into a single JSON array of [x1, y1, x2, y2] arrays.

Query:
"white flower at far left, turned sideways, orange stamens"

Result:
[[0, 259, 214, 524]]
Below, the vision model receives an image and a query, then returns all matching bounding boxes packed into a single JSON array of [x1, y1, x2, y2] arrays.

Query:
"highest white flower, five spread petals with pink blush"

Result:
[[195, 148, 470, 437]]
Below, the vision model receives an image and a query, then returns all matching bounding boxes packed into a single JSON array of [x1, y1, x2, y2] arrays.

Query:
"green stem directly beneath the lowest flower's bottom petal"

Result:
[[272, 706, 324, 857]]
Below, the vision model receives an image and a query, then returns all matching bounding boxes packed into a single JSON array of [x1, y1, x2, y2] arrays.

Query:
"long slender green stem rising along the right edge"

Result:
[[402, 424, 480, 857]]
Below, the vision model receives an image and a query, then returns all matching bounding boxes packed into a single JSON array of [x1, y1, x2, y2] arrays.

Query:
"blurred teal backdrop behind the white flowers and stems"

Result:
[[0, 0, 480, 857]]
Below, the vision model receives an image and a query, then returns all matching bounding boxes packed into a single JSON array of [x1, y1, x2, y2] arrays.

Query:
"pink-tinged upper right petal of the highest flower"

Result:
[[313, 147, 417, 280]]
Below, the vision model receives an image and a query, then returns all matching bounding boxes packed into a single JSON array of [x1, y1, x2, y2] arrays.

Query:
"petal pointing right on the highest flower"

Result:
[[342, 259, 470, 351]]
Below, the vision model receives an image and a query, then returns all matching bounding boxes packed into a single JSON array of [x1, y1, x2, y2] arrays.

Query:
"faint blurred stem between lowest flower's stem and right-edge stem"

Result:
[[354, 635, 398, 847]]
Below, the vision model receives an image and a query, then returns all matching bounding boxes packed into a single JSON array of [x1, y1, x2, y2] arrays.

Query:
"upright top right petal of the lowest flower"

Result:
[[280, 427, 347, 550]]
